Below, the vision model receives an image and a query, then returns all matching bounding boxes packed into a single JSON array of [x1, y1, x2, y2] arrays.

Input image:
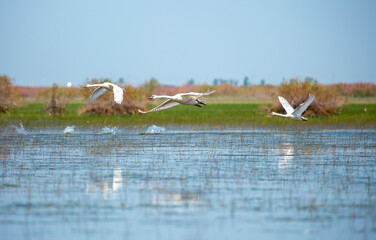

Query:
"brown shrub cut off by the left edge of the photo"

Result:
[[0, 75, 20, 113]]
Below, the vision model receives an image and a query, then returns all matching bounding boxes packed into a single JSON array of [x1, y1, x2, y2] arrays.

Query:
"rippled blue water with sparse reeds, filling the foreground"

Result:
[[0, 128, 376, 239]]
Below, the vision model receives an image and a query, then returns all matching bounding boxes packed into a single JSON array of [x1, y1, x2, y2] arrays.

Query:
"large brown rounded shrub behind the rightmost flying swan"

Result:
[[272, 78, 342, 116]]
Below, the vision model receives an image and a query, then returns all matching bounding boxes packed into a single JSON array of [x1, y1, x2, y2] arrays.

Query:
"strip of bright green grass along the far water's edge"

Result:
[[0, 103, 376, 128]]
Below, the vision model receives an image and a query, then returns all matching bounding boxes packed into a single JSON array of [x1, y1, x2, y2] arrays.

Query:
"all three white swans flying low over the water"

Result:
[[86, 82, 315, 121]]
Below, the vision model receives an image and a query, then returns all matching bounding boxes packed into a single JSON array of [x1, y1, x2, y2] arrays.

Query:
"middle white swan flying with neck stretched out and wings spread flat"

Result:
[[138, 90, 215, 113]]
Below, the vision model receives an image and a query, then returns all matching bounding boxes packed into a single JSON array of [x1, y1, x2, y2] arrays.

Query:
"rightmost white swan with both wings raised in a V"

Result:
[[272, 94, 315, 121]]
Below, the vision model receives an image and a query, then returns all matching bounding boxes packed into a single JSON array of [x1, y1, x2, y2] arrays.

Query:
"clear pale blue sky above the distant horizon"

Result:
[[0, 0, 376, 86]]
